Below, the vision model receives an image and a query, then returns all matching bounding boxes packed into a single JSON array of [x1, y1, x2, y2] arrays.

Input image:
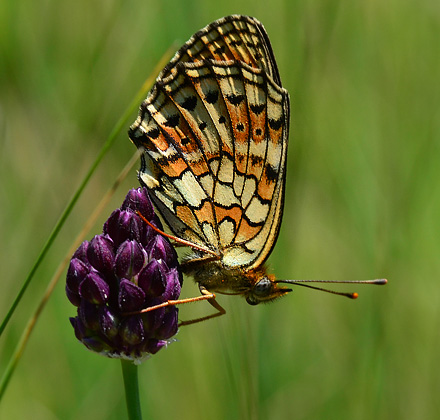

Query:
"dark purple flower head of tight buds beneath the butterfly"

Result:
[[66, 188, 182, 361]]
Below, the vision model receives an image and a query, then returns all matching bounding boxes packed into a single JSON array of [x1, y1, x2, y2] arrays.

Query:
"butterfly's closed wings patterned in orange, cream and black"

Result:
[[129, 15, 289, 271]]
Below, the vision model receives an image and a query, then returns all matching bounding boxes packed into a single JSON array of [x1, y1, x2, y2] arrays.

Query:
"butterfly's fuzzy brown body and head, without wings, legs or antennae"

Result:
[[181, 253, 291, 305]]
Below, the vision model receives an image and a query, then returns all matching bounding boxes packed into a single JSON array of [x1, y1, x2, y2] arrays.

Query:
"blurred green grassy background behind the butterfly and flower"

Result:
[[0, 0, 440, 420]]
